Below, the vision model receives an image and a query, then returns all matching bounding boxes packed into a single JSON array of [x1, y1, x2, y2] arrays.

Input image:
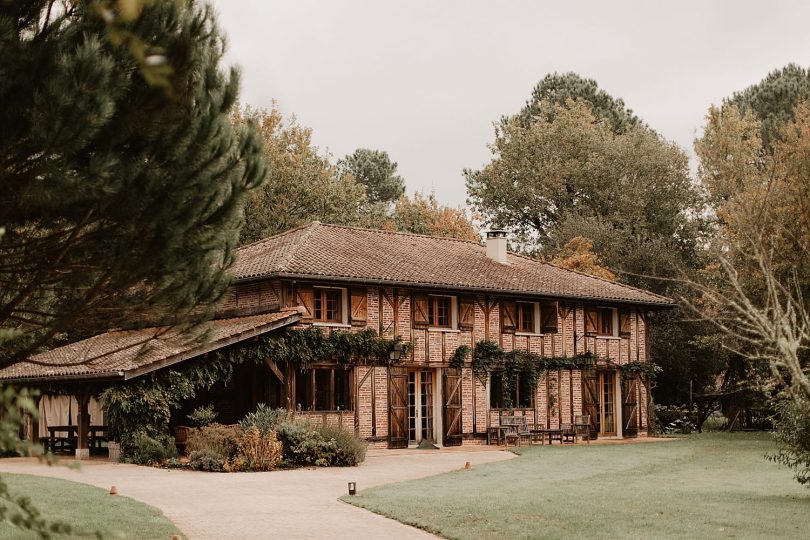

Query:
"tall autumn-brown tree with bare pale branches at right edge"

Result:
[[695, 102, 810, 484]]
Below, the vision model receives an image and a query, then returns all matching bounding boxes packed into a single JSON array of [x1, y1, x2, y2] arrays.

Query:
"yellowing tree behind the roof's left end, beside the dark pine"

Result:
[[234, 107, 368, 244]]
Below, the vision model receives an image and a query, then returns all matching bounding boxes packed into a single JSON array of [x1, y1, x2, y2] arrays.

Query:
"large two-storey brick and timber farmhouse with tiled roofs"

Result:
[[0, 222, 673, 456]]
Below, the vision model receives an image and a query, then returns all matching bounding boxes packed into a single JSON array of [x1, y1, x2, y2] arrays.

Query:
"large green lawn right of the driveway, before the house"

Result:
[[342, 434, 810, 538]]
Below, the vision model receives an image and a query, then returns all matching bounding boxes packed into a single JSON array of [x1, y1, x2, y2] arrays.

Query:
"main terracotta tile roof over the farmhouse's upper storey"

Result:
[[232, 221, 674, 307]]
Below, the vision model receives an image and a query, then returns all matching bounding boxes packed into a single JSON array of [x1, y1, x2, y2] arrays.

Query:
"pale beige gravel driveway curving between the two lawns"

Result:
[[0, 448, 514, 540]]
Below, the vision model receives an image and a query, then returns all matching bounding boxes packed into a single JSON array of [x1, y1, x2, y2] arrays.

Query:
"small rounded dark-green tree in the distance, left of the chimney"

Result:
[[337, 148, 405, 205]]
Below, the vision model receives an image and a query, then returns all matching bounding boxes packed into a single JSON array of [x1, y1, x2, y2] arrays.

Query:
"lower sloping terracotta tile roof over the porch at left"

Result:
[[0, 309, 301, 382]]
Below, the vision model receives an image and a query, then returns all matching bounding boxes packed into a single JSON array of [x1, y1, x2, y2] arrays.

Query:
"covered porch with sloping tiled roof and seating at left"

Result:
[[0, 309, 301, 459]]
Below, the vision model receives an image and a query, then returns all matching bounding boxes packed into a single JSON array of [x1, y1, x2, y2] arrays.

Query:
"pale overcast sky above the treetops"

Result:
[[214, 0, 810, 206]]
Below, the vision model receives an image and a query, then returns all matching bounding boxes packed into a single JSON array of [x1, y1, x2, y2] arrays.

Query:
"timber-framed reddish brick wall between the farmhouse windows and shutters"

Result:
[[249, 276, 647, 445]]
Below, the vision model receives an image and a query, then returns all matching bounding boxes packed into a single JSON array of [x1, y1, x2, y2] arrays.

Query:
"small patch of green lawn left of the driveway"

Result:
[[0, 473, 180, 540]]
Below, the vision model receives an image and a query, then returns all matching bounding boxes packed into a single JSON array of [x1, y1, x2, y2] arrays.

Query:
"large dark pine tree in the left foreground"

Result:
[[0, 0, 265, 362]]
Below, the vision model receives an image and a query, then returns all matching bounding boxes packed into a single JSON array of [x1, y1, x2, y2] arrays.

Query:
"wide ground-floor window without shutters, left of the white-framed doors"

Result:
[[295, 368, 352, 411]]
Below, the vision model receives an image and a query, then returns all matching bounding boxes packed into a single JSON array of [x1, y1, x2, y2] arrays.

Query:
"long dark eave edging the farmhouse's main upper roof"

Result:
[[234, 272, 678, 309]]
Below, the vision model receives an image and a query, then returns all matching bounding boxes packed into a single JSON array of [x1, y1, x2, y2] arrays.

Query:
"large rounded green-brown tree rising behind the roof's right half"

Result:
[[465, 74, 717, 414]]
